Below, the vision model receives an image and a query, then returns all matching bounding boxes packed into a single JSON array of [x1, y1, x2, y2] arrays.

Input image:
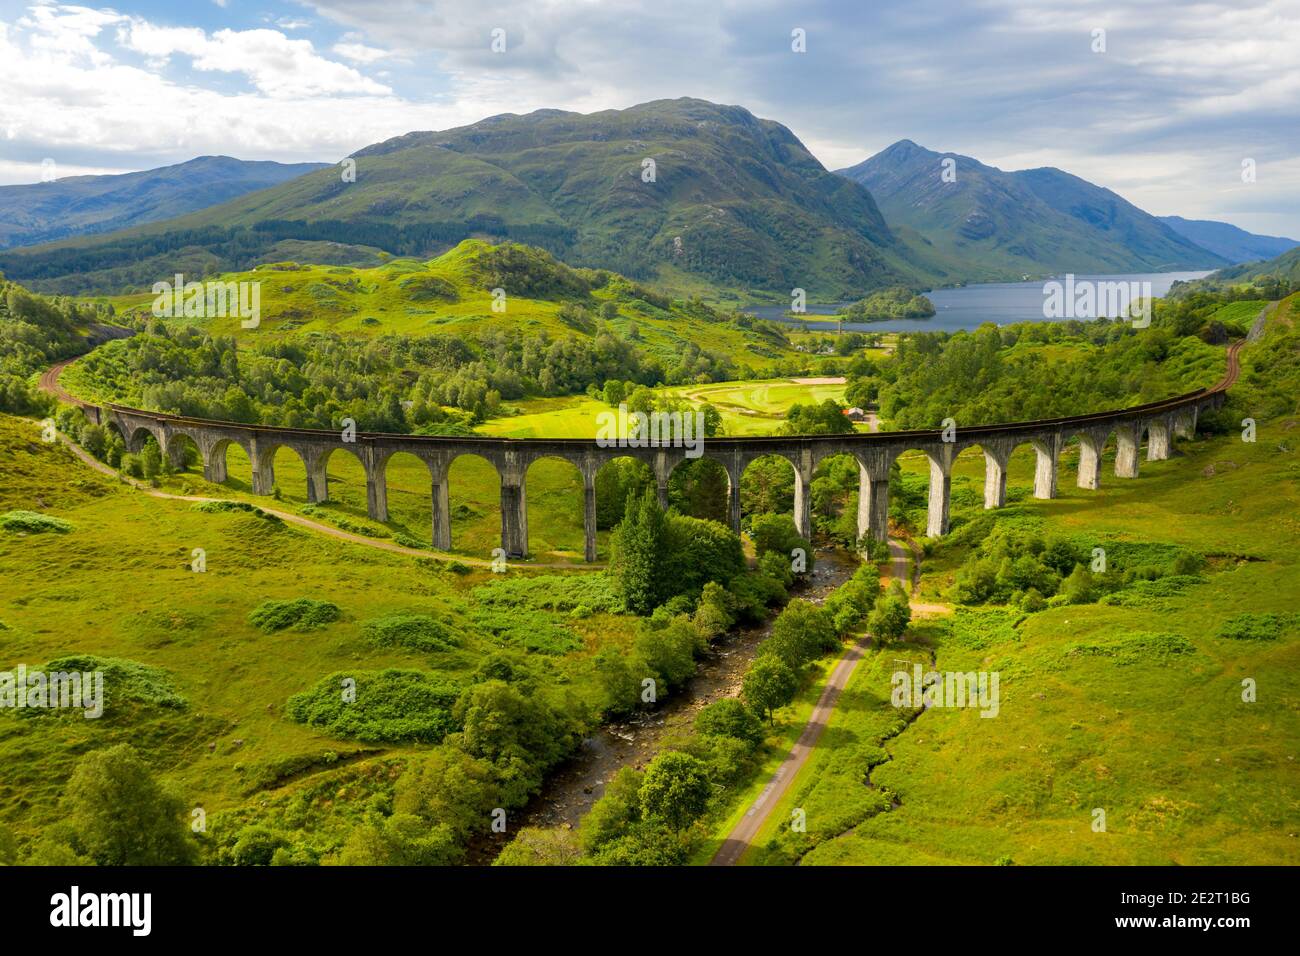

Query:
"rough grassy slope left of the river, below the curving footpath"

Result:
[[0, 416, 633, 852]]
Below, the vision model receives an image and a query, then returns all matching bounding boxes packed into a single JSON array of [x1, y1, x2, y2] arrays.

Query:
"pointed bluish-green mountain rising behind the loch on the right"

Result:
[[840, 139, 1227, 278]]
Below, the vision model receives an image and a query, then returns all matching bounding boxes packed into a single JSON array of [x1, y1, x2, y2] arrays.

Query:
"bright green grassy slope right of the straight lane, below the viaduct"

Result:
[[728, 419, 1300, 865]]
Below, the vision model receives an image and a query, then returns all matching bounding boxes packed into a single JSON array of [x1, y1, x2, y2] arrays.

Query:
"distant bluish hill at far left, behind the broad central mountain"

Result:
[[0, 156, 325, 248]]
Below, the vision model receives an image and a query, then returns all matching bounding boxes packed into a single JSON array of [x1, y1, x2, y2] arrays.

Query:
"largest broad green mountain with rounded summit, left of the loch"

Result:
[[0, 99, 943, 298]]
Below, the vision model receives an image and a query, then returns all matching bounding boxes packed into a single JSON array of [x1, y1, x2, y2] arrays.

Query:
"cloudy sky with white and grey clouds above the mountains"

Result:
[[0, 0, 1300, 238]]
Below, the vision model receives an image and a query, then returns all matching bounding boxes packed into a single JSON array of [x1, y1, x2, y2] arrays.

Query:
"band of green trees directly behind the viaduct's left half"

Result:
[[69, 321, 732, 434]]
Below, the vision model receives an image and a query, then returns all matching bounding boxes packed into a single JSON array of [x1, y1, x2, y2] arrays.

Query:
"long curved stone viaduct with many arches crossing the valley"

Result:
[[86, 343, 1240, 561]]
